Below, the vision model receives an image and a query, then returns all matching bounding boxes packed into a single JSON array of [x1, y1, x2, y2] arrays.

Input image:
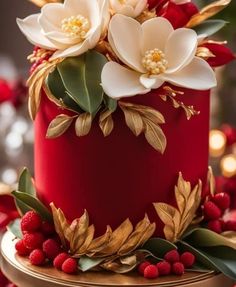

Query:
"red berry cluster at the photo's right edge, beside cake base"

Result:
[[203, 192, 236, 233]]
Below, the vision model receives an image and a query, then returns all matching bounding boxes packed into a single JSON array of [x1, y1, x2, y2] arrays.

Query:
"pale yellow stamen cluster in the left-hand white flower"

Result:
[[61, 15, 90, 38]]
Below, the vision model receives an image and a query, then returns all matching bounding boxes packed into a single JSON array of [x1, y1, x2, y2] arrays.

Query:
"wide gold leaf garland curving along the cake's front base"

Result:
[[51, 203, 156, 260]]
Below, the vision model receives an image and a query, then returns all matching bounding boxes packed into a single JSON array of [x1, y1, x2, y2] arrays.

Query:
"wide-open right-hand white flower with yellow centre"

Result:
[[102, 14, 216, 98]]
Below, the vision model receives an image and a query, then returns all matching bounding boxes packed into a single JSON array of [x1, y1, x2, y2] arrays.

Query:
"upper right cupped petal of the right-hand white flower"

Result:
[[165, 28, 197, 74]]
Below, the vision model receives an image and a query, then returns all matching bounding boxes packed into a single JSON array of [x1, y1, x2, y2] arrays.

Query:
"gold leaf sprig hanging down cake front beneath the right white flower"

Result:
[[119, 101, 167, 153]]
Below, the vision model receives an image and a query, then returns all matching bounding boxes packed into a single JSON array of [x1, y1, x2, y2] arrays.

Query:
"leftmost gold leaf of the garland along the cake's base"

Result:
[[50, 203, 69, 247]]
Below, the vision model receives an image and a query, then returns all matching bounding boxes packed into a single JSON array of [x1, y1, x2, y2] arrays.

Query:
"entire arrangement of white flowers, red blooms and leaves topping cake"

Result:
[[17, 0, 234, 153]]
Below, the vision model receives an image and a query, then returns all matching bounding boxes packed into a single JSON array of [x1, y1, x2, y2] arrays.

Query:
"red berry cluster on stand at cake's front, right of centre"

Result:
[[138, 250, 195, 279]]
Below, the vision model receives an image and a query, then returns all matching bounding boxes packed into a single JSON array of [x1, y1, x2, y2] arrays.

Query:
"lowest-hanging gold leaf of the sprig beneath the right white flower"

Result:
[[143, 118, 167, 154]]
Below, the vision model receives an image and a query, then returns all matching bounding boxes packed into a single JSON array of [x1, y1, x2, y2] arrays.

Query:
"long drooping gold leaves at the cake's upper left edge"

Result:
[[27, 59, 62, 120]]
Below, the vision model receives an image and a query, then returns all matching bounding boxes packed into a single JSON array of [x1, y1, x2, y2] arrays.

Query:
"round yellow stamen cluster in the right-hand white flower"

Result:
[[142, 48, 168, 75]]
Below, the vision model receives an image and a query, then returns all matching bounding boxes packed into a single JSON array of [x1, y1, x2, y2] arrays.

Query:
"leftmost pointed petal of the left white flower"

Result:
[[16, 14, 57, 50]]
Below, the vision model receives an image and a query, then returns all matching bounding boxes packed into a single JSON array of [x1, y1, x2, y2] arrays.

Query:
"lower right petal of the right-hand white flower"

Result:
[[159, 57, 217, 90]]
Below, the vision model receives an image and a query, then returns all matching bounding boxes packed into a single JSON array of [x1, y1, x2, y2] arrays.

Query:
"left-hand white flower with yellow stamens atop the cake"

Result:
[[17, 0, 110, 59]]
